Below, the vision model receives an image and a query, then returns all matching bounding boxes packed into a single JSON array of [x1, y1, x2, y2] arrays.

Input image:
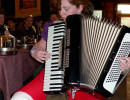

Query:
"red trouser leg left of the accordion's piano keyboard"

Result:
[[19, 70, 46, 100]]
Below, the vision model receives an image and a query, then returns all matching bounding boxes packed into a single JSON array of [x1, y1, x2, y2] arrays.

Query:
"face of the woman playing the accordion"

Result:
[[60, 0, 83, 21]]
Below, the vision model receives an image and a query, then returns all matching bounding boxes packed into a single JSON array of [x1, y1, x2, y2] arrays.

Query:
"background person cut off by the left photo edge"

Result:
[[0, 8, 10, 36]]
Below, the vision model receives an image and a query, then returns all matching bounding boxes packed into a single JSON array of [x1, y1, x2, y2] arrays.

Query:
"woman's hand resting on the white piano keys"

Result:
[[32, 49, 51, 63]]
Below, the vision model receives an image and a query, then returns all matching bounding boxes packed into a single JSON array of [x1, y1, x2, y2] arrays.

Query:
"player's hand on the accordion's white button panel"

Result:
[[118, 57, 130, 74]]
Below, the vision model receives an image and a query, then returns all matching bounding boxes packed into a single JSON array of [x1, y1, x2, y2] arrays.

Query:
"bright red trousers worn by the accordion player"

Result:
[[18, 69, 104, 100]]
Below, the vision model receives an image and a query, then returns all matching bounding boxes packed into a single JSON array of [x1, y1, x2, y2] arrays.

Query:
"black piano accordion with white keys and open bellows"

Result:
[[43, 15, 130, 97]]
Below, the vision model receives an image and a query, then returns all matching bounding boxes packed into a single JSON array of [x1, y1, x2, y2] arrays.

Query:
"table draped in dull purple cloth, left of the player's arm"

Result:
[[0, 50, 40, 100]]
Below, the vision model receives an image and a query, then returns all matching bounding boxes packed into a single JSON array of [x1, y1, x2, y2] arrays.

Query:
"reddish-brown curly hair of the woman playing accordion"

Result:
[[54, 0, 94, 15]]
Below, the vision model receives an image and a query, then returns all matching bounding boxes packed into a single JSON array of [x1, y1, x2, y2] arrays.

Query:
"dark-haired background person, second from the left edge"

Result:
[[6, 17, 17, 37]]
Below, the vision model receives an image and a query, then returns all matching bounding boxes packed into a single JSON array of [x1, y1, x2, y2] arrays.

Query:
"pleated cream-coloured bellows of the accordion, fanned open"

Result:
[[80, 17, 122, 89]]
